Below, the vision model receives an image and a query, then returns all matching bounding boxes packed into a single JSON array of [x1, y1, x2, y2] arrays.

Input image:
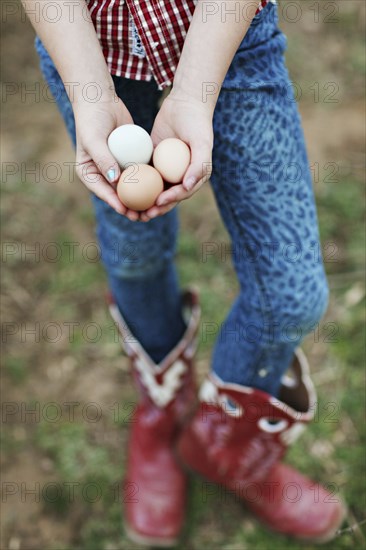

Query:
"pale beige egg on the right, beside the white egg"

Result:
[[153, 138, 191, 183]]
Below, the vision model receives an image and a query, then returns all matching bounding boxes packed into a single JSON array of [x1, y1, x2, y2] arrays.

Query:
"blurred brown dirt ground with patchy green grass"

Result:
[[0, 0, 366, 550]]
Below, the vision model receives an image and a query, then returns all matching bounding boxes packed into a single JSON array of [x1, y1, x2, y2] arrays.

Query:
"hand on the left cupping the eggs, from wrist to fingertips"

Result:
[[74, 96, 139, 221]]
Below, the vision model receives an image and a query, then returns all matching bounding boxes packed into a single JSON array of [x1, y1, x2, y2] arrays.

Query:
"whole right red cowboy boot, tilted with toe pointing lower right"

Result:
[[177, 350, 345, 542]]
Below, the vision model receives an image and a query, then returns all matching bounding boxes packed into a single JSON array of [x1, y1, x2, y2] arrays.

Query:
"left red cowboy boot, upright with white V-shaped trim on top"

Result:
[[109, 292, 200, 547]]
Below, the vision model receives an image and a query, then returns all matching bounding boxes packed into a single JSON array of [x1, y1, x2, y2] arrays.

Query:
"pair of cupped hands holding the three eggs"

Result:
[[74, 90, 213, 222]]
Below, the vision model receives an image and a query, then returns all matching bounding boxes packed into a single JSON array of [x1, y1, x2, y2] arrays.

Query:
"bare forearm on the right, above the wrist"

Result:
[[172, 0, 258, 108]]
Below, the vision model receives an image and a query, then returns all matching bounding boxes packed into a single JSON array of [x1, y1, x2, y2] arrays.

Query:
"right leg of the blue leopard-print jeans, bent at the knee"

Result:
[[211, 4, 328, 395]]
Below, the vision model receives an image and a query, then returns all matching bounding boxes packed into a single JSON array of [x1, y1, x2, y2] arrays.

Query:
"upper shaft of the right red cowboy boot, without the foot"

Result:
[[179, 350, 316, 485]]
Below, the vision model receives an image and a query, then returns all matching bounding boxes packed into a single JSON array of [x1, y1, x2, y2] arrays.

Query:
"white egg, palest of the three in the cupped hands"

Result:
[[108, 124, 153, 168]]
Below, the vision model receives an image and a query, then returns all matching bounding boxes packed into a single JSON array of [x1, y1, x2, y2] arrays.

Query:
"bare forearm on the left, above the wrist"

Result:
[[22, 0, 114, 103]]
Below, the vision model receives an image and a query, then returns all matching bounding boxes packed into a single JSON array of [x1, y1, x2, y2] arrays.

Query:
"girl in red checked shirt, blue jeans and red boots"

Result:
[[24, 0, 344, 546]]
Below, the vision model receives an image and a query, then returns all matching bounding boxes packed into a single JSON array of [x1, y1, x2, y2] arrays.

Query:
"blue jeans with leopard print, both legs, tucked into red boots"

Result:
[[36, 4, 328, 395]]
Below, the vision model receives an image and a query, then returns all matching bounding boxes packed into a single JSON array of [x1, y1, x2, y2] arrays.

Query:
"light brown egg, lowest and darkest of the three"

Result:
[[117, 164, 164, 210]]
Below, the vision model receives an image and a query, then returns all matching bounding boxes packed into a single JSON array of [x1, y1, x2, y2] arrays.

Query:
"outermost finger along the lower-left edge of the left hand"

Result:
[[76, 161, 127, 215]]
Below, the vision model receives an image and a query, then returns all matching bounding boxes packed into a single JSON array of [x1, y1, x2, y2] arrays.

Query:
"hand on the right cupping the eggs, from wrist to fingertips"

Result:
[[140, 88, 213, 222]]
